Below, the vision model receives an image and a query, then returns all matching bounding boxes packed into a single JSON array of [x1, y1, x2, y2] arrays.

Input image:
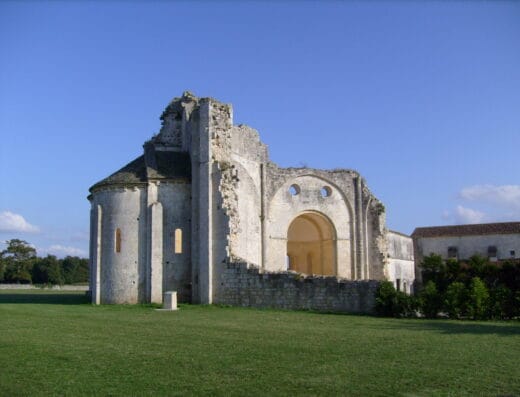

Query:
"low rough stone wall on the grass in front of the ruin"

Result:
[[216, 263, 379, 313]]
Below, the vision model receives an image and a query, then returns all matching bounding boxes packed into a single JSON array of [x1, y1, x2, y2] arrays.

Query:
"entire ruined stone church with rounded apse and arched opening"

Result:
[[89, 92, 413, 311]]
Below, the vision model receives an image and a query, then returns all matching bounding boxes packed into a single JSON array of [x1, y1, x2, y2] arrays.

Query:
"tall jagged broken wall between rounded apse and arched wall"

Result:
[[200, 100, 267, 304]]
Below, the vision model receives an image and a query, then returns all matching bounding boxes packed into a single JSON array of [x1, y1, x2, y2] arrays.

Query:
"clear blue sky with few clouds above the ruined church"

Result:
[[0, 1, 520, 256]]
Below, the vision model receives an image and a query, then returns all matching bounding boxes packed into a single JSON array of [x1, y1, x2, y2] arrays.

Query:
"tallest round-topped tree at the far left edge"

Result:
[[0, 239, 36, 284]]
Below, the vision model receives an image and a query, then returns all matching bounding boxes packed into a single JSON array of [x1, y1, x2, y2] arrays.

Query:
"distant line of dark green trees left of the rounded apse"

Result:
[[0, 239, 89, 285]]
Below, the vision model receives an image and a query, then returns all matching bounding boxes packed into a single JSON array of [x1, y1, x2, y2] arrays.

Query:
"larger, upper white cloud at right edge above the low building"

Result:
[[459, 185, 520, 210]]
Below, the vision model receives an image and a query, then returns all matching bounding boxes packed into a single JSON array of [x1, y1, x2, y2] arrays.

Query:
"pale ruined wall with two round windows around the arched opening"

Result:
[[264, 163, 387, 280]]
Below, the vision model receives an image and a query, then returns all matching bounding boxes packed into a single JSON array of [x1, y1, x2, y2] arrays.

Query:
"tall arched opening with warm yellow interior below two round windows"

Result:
[[287, 212, 336, 276]]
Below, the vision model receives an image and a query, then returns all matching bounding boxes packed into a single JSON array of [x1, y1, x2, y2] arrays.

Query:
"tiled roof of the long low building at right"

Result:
[[412, 222, 520, 237]]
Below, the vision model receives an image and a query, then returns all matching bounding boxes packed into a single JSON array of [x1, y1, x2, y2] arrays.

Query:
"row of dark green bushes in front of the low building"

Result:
[[376, 254, 520, 320]]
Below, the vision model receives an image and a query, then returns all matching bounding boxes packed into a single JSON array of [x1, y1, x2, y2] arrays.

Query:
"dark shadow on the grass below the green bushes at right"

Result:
[[379, 319, 520, 336]]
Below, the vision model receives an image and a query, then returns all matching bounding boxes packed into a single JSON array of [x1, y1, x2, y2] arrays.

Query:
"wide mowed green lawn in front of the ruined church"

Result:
[[0, 291, 520, 396]]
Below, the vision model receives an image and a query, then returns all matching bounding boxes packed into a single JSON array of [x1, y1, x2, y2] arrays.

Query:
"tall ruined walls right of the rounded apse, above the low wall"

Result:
[[183, 93, 386, 303]]
